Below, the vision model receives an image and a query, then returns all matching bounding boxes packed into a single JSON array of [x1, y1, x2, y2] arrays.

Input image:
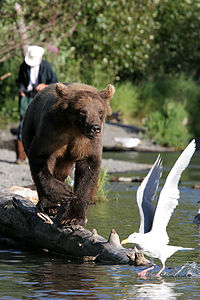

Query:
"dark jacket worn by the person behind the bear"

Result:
[[17, 60, 58, 93]]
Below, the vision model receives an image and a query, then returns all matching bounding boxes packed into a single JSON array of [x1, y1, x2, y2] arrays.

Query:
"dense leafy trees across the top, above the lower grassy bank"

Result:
[[0, 0, 200, 84]]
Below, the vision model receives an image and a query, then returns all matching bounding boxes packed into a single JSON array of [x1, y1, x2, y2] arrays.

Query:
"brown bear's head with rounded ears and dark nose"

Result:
[[54, 83, 115, 139]]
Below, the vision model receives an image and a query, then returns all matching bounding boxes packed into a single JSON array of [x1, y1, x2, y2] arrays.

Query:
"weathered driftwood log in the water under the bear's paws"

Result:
[[0, 192, 149, 265]]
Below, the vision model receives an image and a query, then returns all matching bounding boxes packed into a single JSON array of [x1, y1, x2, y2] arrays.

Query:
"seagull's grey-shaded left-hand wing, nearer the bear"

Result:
[[137, 155, 162, 233]]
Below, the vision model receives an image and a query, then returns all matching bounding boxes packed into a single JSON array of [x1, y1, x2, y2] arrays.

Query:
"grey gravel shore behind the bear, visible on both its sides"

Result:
[[0, 123, 163, 192]]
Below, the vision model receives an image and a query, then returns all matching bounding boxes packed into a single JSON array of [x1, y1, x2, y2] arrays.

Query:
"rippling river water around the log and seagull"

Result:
[[0, 152, 200, 300]]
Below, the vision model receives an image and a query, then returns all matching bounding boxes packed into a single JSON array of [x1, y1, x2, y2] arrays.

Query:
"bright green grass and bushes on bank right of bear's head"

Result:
[[111, 74, 200, 149]]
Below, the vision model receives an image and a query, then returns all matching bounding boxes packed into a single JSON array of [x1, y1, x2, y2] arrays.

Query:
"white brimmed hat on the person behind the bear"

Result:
[[25, 46, 44, 67]]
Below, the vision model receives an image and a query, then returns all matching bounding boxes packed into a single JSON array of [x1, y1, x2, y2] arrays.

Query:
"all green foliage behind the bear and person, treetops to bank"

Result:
[[0, 0, 200, 145]]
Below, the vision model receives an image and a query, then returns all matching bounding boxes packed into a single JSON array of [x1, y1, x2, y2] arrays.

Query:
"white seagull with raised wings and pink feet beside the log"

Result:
[[121, 140, 196, 277]]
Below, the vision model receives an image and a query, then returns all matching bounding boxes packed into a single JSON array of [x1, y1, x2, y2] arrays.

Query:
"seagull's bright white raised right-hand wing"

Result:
[[151, 140, 196, 243]]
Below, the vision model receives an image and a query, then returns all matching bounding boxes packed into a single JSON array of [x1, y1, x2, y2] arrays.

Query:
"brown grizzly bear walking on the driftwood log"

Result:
[[22, 83, 115, 226]]
